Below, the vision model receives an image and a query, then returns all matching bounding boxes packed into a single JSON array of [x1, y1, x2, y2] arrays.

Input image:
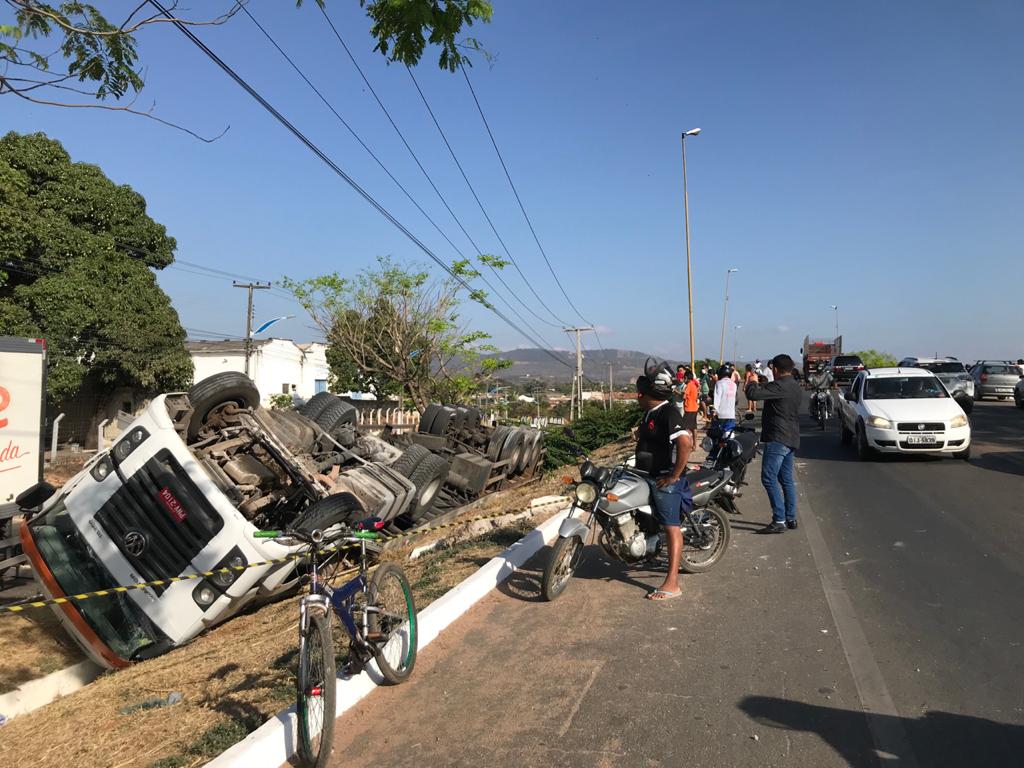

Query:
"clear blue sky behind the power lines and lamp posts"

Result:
[[0, 0, 1024, 359]]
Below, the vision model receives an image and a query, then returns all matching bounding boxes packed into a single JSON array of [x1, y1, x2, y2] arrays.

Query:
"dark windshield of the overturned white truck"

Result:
[[30, 502, 163, 659]]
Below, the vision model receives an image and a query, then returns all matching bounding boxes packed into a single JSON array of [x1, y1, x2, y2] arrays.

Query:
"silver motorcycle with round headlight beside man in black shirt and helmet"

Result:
[[541, 429, 732, 600]]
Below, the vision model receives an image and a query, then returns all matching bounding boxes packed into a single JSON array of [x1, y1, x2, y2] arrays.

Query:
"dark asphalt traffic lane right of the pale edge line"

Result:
[[799, 402, 1024, 766]]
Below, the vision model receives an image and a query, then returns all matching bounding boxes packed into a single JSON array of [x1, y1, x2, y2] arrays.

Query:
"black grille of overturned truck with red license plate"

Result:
[[96, 450, 224, 594]]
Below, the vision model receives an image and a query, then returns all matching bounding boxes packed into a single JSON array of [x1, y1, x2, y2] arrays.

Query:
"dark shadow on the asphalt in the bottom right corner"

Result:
[[739, 696, 1024, 768]]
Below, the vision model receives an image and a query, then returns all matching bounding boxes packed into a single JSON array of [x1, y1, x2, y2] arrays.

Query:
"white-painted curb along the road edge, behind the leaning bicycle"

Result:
[[207, 509, 568, 768]]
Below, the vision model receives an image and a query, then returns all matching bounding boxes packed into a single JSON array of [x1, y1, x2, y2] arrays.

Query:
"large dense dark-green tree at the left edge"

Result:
[[0, 133, 193, 401]]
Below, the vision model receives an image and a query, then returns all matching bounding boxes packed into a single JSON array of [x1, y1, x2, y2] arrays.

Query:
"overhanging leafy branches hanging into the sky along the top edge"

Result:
[[0, 0, 493, 135]]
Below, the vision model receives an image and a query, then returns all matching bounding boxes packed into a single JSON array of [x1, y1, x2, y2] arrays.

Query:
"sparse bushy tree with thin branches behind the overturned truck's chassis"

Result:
[[284, 258, 510, 410]]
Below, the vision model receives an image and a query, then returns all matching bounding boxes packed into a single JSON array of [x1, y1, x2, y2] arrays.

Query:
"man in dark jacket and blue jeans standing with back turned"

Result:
[[746, 354, 804, 534]]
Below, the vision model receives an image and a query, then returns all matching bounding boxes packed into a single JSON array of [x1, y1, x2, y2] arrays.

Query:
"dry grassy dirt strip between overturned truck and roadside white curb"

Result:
[[0, 441, 630, 768]]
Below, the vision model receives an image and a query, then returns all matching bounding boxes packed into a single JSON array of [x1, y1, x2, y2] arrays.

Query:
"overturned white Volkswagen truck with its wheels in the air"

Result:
[[18, 373, 544, 668]]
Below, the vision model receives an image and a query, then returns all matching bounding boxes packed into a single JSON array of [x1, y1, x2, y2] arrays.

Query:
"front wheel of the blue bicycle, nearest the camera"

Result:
[[296, 615, 337, 768]]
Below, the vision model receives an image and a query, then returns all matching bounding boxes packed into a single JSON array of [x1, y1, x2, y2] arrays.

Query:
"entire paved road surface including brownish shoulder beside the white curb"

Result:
[[321, 403, 1024, 768]]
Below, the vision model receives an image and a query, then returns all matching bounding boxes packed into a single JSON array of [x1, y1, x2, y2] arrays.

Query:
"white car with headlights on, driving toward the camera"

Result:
[[839, 368, 971, 460]]
